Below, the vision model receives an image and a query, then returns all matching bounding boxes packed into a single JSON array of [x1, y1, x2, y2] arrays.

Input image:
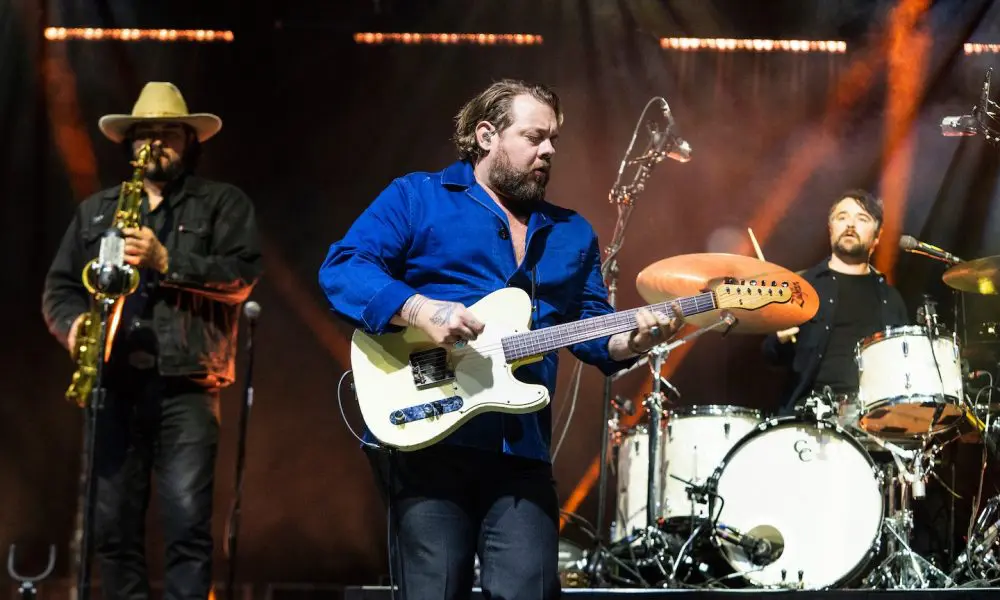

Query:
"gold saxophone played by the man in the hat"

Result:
[[66, 143, 159, 408]]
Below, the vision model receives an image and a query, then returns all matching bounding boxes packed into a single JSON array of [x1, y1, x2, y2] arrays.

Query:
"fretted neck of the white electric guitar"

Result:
[[502, 292, 718, 362]]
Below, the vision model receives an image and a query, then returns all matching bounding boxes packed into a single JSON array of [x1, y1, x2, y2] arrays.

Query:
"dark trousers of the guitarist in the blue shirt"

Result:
[[366, 444, 560, 600]]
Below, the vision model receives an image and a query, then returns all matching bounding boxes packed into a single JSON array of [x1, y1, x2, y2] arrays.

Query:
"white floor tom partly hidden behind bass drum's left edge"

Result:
[[663, 405, 761, 519]]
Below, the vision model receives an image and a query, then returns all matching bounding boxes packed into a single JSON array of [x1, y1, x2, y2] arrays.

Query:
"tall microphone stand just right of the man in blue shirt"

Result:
[[587, 96, 690, 583]]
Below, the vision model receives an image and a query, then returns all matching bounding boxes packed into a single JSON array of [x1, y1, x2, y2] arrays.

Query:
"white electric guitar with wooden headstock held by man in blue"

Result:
[[351, 281, 795, 451]]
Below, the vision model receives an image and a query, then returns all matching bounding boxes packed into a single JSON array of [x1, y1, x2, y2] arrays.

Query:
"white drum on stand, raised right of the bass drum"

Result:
[[856, 326, 963, 438]]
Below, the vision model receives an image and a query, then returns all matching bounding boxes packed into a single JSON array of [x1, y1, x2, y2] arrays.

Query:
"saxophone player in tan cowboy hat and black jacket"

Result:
[[42, 82, 261, 600]]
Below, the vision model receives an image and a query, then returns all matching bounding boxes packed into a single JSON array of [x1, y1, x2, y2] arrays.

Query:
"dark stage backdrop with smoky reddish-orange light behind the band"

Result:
[[0, 0, 1000, 583]]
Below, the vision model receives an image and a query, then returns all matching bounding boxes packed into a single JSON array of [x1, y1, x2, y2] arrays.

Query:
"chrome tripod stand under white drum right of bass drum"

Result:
[[864, 432, 954, 589]]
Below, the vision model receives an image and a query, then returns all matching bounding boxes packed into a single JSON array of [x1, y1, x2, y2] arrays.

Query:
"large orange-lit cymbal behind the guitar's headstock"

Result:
[[636, 253, 819, 334]]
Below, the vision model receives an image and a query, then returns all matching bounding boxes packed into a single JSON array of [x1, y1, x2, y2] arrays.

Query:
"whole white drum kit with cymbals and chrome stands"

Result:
[[574, 248, 1000, 590]]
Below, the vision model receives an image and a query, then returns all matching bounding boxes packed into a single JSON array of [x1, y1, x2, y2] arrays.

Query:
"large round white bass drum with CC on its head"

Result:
[[709, 417, 883, 589]]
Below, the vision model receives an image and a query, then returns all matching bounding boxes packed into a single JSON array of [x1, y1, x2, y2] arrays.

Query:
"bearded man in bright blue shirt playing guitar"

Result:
[[319, 80, 680, 600]]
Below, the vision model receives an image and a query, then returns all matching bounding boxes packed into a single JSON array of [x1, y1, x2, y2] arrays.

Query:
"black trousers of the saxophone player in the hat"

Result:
[[94, 369, 219, 600]]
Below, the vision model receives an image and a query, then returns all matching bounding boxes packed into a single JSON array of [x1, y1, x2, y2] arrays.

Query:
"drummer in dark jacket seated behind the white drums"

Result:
[[763, 190, 907, 414]]
